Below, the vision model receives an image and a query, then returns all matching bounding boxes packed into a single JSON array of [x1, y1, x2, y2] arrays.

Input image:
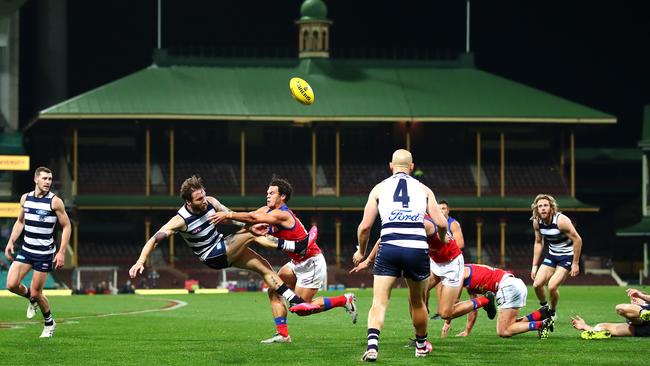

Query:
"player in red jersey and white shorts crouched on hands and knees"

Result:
[[445, 264, 553, 338]]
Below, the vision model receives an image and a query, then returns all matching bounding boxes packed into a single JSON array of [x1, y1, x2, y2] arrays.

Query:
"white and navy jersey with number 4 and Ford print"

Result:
[[378, 173, 429, 249]]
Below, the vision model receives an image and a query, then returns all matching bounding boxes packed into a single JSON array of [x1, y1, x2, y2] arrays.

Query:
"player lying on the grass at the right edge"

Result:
[[571, 288, 650, 339]]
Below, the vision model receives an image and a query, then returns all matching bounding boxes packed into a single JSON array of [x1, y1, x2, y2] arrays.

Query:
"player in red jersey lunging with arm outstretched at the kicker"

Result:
[[211, 177, 357, 343]]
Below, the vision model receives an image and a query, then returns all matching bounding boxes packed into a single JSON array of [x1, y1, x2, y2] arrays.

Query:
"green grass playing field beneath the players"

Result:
[[0, 286, 650, 366]]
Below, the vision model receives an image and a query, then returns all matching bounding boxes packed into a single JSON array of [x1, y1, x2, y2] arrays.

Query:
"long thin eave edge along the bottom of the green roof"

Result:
[[39, 113, 617, 125]]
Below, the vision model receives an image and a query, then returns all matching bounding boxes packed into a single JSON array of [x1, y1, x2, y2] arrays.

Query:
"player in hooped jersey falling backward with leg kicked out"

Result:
[[129, 176, 304, 316]]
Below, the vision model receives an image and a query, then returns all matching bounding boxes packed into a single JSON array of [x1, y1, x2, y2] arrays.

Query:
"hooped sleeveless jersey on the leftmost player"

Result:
[[22, 191, 58, 255]]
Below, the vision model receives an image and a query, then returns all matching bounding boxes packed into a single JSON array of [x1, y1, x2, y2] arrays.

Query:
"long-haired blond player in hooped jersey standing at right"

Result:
[[530, 194, 582, 317]]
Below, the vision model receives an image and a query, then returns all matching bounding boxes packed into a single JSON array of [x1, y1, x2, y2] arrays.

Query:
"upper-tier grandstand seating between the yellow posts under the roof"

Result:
[[79, 159, 569, 196]]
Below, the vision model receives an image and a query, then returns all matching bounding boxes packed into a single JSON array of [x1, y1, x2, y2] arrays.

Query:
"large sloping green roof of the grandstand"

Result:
[[39, 51, 616, 124]]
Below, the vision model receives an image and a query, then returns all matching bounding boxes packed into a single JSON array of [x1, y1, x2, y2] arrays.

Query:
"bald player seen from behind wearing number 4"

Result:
[[352, 149, 447, 362]]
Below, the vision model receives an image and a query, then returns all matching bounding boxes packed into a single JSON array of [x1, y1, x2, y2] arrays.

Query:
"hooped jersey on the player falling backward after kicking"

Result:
[[178, 203, 225, 261]]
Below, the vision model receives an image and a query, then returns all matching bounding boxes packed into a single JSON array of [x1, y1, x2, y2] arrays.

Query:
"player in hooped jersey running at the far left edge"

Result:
[[5, 167, 71, 338]]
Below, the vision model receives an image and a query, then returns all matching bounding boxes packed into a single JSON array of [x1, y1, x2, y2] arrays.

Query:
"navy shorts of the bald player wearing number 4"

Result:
[[375, 244, 431, 281]]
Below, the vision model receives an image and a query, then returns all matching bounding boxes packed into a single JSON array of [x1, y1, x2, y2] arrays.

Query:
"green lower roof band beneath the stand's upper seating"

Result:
[[73, 195, 599, 212]]
